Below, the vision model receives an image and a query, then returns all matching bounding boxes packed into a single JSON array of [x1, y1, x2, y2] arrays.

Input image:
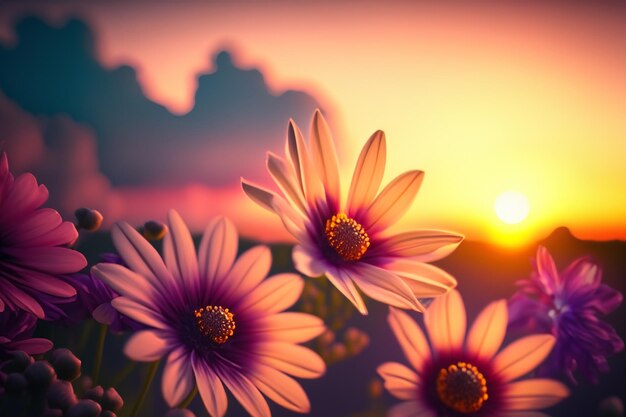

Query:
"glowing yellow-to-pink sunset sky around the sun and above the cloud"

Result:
[[0, 1, 626, 243]]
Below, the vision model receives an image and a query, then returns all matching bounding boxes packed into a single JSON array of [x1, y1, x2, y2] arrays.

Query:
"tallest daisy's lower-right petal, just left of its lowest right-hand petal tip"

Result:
[[346, 263, 422, 311]]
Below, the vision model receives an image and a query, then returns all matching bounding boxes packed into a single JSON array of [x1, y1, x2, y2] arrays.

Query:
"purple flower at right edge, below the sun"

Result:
[[509, 246, 624, 383]]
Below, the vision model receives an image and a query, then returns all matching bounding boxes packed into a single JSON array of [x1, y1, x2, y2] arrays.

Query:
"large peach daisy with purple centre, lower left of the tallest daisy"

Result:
[[93, 211, 325, 417]]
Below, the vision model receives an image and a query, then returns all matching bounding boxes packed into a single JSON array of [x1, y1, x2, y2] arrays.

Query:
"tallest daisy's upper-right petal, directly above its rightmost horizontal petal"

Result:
[[363, 171, 424, 230]]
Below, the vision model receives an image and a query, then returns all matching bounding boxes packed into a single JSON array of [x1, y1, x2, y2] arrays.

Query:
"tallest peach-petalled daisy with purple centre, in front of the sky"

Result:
[[242, 110, 463, 314]]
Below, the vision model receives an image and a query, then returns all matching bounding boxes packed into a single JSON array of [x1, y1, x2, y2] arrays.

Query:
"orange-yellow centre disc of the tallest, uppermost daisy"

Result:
[[325, 213, 370, 261]]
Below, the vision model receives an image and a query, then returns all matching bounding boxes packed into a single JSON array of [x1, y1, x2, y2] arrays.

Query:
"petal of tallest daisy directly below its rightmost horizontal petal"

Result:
[[384, 259, 457, 298]]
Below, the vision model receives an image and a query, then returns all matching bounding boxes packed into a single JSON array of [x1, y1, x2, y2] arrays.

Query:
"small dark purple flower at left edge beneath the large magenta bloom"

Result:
[[0, 310, 52, 360]]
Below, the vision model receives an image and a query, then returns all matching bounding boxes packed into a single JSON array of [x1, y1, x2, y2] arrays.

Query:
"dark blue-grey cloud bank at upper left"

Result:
[[0, 17, 320, 186]]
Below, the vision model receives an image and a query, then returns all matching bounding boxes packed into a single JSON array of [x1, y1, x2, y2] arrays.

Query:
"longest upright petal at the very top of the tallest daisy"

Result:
[[311, 110, 341, 201]]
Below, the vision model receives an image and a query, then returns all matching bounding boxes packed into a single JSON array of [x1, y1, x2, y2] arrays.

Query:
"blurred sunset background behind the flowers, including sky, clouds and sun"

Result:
[[0, 0, 626, 416]]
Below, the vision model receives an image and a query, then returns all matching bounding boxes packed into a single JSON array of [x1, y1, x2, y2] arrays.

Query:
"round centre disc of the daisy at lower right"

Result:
[[437, 362, 488, 414]]
